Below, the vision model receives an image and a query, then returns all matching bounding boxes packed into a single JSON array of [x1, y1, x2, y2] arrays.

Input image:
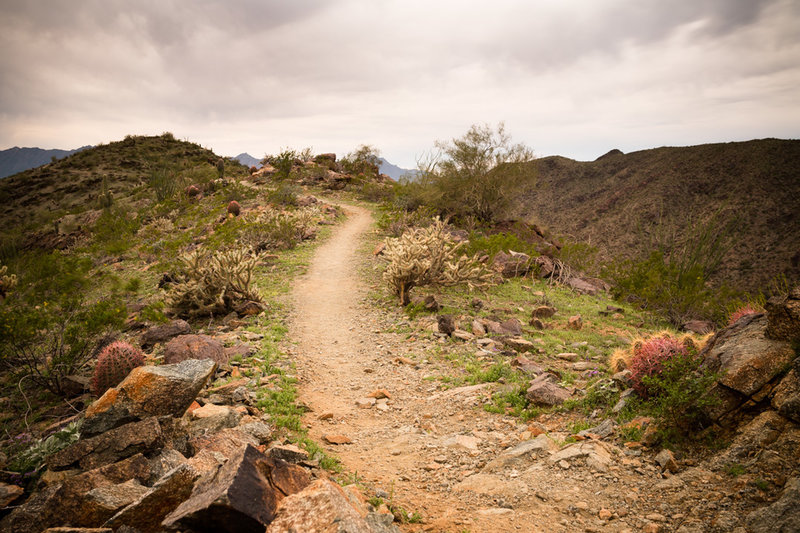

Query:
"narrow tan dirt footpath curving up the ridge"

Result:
[[290, 206, 566, 532]]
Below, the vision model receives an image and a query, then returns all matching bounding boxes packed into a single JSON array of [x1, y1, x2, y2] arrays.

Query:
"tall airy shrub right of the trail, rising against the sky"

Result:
[[417, 123, 536, 222]]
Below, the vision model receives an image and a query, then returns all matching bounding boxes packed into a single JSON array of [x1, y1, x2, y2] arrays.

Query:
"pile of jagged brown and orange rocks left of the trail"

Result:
[[0, 359, 397, 533]]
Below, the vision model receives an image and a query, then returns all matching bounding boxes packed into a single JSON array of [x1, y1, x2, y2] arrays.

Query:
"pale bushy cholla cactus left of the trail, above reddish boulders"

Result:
[[167, 249, 261, 316]]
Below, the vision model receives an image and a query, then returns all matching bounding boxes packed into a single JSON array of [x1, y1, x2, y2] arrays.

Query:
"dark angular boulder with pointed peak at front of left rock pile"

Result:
[[163, 445, 310, 533]]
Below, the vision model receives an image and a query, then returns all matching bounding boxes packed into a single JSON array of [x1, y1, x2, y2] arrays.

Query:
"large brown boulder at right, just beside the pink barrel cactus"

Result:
[[701, 315, 795, 396]]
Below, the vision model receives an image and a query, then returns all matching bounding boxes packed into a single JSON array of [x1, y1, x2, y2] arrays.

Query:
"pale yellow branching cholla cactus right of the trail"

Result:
[[383, 219, 496, 305]]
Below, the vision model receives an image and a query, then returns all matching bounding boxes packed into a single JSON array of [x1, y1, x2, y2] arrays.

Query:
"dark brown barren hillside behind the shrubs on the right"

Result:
[[524, 139, 800, 290]]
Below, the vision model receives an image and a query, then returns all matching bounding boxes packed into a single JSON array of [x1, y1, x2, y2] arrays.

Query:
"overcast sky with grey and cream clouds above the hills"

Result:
[[0, 0, 800, 167]]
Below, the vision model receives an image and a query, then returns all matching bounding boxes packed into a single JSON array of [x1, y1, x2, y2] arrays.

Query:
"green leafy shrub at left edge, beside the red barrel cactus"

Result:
[[0, 253, 127, 395]]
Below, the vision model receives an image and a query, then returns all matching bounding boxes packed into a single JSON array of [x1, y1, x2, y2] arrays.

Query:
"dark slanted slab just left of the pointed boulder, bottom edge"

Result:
[[103, 464, 198, 533]]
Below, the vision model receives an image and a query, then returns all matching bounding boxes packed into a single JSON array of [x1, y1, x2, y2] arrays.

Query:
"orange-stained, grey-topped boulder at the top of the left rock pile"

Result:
[[81, 359, 217, 437]]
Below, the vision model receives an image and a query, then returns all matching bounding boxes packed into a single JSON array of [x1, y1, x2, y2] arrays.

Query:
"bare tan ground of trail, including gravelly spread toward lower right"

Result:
[[289, 205, 700, 532]]
